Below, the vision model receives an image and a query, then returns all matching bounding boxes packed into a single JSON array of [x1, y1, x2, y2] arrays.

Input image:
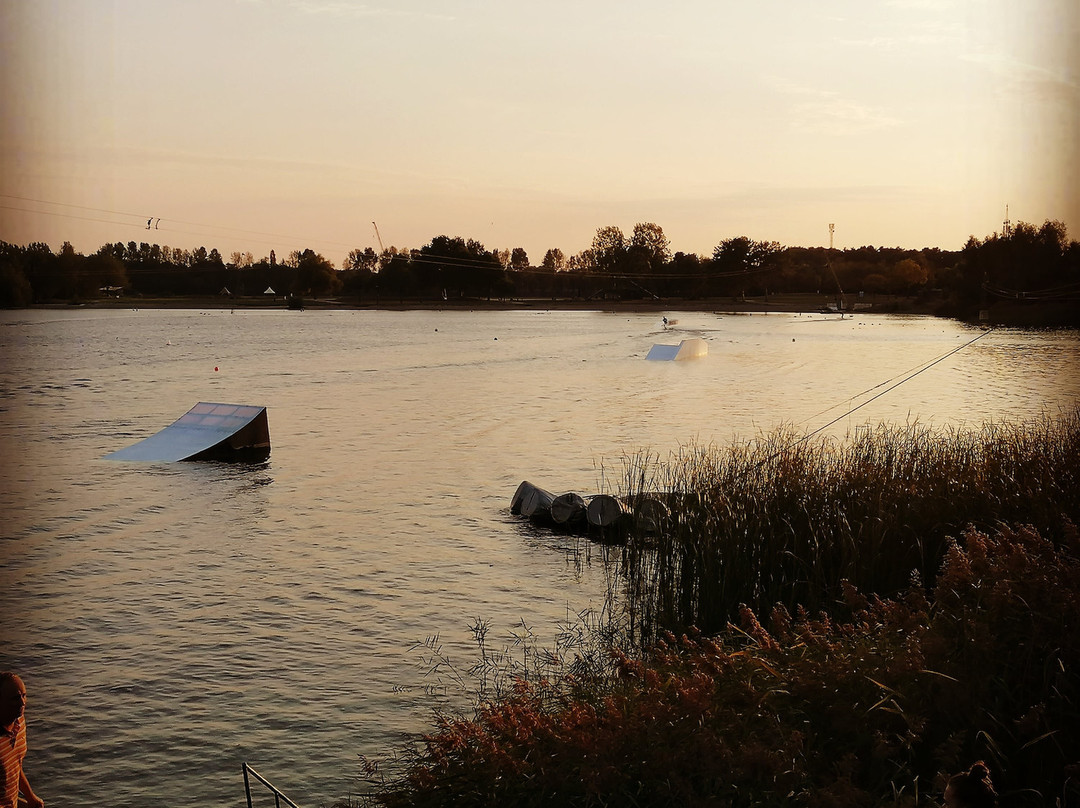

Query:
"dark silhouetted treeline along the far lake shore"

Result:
[[0, 221, 1080, 324]]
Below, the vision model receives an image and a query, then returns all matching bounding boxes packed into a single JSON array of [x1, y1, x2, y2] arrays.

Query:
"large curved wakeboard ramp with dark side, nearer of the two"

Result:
[[105, 402, 270, 462]]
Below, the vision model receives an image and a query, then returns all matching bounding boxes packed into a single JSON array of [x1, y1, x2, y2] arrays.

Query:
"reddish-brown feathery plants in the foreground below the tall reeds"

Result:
[[369, 526, 1080, 808]]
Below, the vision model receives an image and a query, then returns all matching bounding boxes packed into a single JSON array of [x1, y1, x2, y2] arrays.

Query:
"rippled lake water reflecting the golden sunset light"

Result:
[[0, 309, 1080, 806]]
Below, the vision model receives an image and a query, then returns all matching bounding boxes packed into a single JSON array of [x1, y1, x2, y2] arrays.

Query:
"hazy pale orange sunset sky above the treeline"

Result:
[[0, 0, 1080, 265]]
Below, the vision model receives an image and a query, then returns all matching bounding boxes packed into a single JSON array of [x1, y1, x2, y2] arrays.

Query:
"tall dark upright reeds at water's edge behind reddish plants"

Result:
[[620, 407, 1080, 647]]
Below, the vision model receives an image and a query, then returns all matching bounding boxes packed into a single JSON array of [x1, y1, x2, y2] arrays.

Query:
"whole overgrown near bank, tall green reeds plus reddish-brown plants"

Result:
[[356, 409, 1080, 807]]
